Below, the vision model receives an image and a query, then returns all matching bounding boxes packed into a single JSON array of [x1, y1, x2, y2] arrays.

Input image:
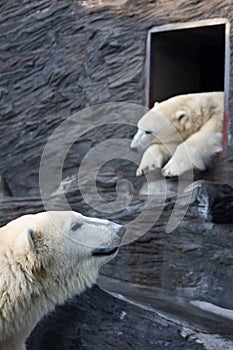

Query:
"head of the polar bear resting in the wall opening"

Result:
[[130, 93, 217, 151]]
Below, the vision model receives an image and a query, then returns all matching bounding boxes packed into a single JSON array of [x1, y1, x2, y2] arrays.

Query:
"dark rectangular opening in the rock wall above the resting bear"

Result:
[[147, 24, 225, 108]]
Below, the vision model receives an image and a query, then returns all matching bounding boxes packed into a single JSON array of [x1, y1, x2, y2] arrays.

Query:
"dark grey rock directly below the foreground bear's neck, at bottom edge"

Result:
[[28, 287, 204, 350]]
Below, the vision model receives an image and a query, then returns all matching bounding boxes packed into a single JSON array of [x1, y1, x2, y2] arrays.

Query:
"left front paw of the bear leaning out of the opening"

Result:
[[136, 144, 169, 176]]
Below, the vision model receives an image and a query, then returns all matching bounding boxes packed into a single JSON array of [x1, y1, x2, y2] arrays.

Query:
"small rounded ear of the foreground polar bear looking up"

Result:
[[15, 227, 36, 254]]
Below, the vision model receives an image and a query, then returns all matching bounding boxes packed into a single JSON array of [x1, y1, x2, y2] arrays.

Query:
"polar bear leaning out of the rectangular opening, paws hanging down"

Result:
[[130, 92, 224, 177]]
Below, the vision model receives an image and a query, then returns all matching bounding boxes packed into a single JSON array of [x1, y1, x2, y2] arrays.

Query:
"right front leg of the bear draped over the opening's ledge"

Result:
[[162, 118, 222, 177]]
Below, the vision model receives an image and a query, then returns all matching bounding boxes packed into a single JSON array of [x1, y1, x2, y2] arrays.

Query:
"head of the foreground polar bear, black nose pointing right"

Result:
[[0, 211, 124, 293]]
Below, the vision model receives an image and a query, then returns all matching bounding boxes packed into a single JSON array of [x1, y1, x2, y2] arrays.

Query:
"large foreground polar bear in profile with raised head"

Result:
[[0, 211, 125, 350]]
